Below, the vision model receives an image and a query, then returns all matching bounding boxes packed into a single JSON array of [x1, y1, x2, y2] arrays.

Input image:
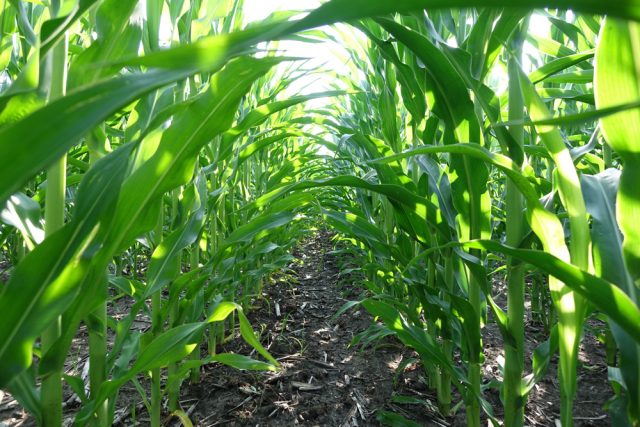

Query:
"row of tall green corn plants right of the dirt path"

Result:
[[324, 10, 638, 425]]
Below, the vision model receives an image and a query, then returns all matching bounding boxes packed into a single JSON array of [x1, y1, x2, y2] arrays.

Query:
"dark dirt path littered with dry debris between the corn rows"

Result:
[[175, 232, 446, 426]]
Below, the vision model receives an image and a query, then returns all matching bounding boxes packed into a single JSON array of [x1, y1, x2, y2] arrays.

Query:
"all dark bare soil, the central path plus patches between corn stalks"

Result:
[[0, 231, 612, 427]]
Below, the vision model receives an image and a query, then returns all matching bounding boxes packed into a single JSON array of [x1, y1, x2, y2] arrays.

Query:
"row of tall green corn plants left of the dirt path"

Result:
[[2, 1, 338, 425]]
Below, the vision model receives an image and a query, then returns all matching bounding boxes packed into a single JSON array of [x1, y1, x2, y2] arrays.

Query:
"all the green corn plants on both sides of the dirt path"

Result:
[[0, 0, 640, 426]]
